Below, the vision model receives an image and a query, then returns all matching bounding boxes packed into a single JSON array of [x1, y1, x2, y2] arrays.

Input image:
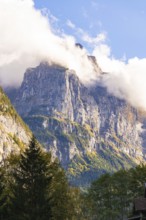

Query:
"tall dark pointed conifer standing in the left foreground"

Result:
[[11, 137, 52, 220]]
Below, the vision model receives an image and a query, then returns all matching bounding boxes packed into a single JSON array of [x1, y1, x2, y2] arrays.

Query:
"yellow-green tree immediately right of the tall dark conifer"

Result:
[[50, 161, 80, 220]]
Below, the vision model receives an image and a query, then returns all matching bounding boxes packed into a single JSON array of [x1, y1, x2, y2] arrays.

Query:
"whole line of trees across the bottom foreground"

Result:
[[0, 137, 146, 220]]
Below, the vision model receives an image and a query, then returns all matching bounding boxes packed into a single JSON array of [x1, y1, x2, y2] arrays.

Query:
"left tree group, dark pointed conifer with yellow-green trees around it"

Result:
[[0, 137, 82, 220]]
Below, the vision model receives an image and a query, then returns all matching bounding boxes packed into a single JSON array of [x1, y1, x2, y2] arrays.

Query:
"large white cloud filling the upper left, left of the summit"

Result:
[[0, 0, 96, 86]]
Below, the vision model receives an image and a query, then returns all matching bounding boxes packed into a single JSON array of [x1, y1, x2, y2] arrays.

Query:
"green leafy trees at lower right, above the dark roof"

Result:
[[87, 165, 146, 220]]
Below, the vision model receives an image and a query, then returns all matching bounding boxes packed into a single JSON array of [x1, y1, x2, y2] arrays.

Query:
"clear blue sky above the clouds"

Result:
[[34, 0, 146, 58]]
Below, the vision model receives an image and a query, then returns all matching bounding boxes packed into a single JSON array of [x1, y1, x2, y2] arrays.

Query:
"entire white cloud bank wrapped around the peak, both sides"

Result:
[[0, 0, 146, 110]]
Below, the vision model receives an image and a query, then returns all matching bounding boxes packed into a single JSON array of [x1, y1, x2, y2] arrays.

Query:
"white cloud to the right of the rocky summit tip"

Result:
[[93, 44, 146, 110]]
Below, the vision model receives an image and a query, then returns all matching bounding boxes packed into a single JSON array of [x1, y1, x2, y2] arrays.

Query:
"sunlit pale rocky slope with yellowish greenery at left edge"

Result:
[[0, 88, 31, 161]]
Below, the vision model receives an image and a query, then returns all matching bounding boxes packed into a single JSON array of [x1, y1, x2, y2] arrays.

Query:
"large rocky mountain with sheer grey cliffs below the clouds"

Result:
[[8, 63, 146, 184]]
